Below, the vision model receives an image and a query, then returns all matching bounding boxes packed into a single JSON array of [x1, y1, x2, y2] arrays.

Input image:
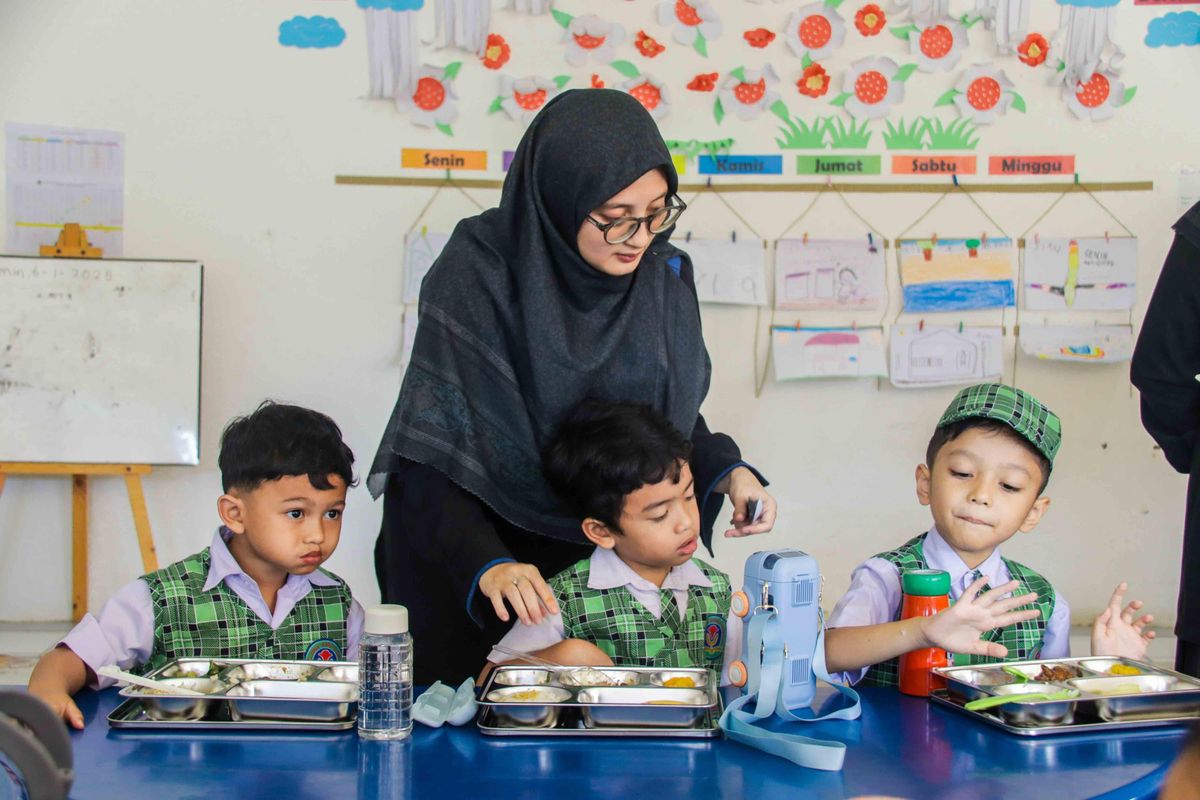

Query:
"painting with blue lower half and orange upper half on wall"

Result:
[[898, 236, 1016, 313]]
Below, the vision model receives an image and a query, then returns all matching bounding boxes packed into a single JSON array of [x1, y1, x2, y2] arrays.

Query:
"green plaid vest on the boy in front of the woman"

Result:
[[550, 559, 730, 672]]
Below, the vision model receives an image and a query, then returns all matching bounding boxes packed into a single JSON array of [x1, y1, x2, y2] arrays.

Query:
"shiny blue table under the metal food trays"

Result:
[[25, 688, 1184, 800]]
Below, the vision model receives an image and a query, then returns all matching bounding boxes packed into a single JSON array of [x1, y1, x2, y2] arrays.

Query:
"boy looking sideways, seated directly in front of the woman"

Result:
[[488, 401, 742, 679]]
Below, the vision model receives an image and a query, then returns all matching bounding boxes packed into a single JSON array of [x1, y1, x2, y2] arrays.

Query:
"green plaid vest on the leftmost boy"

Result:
[[133, 547, 350, 674]]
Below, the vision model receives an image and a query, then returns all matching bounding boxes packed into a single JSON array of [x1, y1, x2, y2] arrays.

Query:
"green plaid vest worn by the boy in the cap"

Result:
[[860, 534, 1055, 686]]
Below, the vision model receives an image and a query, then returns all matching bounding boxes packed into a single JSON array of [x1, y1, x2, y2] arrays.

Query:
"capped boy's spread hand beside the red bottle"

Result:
[[914, 576, 1039, 658]]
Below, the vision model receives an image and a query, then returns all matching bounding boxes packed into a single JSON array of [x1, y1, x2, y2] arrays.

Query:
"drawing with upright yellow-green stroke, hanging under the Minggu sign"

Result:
[[1024, 236, 1138, 311]]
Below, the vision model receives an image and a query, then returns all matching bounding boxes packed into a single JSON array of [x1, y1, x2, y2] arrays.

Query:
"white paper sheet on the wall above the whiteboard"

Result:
[[4, 122, 125, 258]]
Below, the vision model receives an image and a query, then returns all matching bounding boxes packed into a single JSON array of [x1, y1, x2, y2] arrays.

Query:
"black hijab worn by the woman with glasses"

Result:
[[367, 89, 710, 541]]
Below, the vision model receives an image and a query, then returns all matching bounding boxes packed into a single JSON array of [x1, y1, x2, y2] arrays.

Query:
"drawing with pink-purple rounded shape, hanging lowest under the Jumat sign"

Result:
[[770, 326, 888, 380]]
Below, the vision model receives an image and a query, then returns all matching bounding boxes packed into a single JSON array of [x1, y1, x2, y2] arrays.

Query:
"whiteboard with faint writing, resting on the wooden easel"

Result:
[[0, 255, 204, 464]]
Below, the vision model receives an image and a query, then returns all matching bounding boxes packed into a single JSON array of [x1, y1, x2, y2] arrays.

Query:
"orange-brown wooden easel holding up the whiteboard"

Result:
[[0, 222, 158, 622]]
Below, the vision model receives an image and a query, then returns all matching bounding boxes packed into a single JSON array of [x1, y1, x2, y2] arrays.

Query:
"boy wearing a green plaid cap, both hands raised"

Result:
[[826, 384, 1154, 686]]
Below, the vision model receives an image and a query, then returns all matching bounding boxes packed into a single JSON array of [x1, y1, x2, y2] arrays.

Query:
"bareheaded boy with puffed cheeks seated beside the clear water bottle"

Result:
[[29, 401, 362, 728]]
